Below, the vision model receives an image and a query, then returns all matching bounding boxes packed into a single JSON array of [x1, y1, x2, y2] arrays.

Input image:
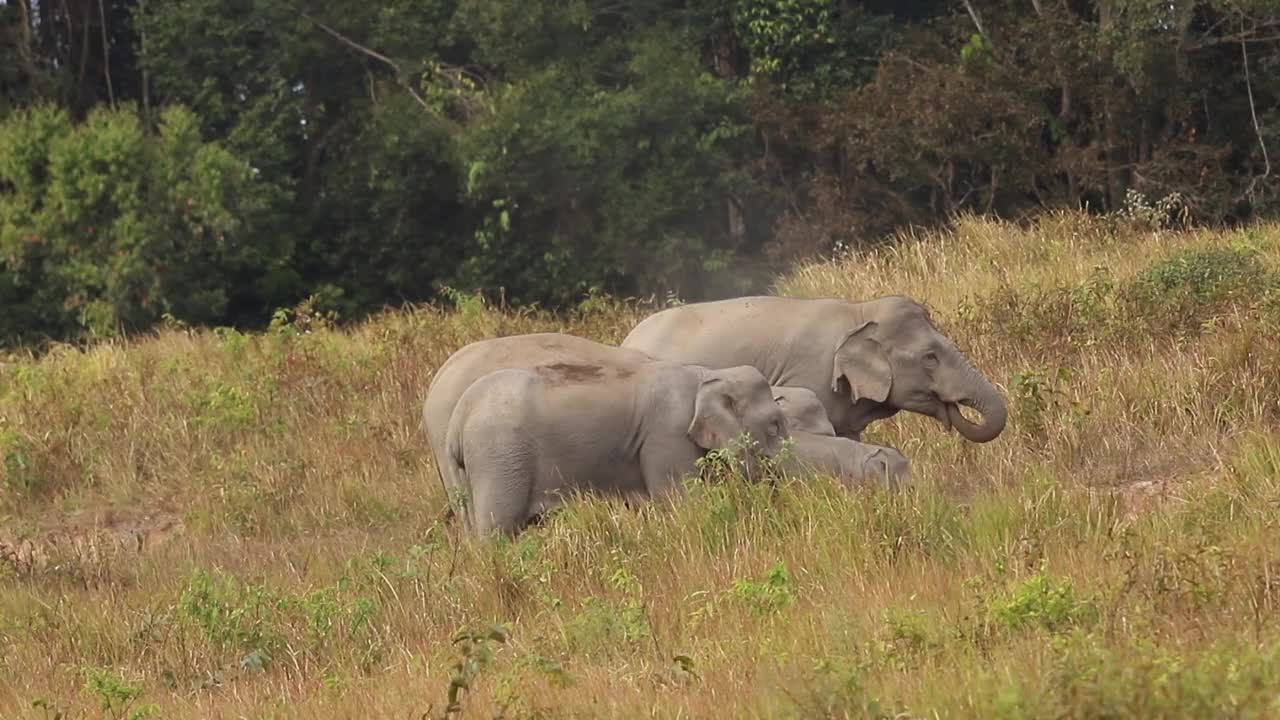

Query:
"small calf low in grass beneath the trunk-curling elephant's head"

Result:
[[778, 430, 911, 489]]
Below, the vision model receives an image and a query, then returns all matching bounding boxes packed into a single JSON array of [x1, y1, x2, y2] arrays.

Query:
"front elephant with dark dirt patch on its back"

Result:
[[443, 361, 787, 536]]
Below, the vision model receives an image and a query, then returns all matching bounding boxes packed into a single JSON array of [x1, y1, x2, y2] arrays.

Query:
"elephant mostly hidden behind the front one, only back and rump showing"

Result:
[[422, 333, 654, 509]]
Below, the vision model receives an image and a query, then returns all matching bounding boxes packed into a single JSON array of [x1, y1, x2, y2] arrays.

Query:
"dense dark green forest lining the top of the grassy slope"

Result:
[[0, 0, 1280, 343]]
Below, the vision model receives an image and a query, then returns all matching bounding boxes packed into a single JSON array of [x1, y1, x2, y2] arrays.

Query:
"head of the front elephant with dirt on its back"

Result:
[[689, 365, 790, 466]]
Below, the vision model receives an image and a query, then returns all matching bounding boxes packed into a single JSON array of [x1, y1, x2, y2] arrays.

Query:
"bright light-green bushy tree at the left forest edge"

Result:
[[0, 105, 289, 338]]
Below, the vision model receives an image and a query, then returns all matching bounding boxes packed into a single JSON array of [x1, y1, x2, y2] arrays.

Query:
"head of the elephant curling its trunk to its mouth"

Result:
[[831, 296, 1007, 442]]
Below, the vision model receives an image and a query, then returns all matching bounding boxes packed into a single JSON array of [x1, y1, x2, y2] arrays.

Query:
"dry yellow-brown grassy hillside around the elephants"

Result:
[[0, 210, 1280, 717]]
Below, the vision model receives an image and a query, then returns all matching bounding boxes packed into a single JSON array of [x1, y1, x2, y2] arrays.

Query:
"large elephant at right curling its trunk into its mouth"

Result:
[[621, 295, 1007, 442]]
